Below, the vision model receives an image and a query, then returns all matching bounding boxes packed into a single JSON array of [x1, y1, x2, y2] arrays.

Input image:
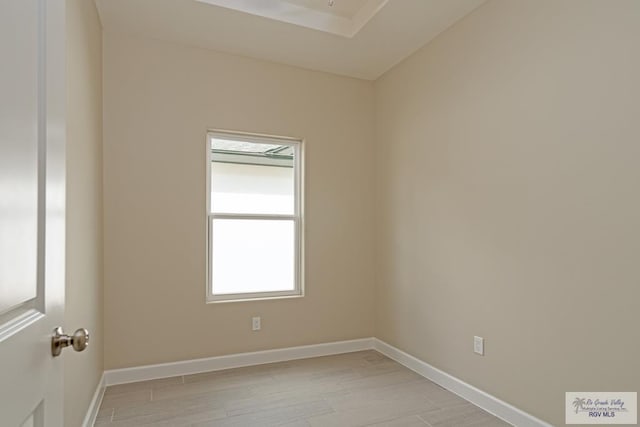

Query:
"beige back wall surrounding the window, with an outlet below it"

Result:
[[104, 31, 374, 369]]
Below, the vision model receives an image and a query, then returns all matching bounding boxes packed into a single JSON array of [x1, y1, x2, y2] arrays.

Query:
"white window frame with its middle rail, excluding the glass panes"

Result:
[[206, 130, 304, 303]]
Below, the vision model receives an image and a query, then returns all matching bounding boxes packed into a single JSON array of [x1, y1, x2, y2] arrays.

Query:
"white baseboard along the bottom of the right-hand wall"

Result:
[[373, 338, 553, 427]]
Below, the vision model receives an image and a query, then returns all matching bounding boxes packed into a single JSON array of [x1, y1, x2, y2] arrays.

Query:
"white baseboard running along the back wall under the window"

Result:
[[104, 338, 374, 386]]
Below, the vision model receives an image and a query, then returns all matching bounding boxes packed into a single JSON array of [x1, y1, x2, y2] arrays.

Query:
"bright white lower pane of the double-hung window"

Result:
[[210, 219, 296, 295]]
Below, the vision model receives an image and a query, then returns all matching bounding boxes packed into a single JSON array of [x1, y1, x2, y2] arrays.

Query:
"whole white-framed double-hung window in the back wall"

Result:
[[207, 132, 303, 301]]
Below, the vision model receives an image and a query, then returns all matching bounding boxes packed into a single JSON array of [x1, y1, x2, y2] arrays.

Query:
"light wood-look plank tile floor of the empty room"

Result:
[[95, 351, 509, 427]]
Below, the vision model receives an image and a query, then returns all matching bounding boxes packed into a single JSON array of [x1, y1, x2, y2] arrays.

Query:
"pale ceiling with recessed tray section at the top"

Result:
[[96, 0, 486, 80]]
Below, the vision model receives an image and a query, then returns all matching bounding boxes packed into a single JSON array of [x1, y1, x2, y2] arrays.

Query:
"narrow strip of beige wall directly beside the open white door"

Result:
[[64, 0, 104, 426]]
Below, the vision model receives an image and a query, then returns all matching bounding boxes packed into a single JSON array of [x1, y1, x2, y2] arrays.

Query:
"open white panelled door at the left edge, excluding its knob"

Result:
[[0, 0, 66, 427]]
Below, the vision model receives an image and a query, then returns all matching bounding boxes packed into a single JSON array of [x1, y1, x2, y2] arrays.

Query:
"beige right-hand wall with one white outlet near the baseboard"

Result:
[[375, 0, 640, 425]]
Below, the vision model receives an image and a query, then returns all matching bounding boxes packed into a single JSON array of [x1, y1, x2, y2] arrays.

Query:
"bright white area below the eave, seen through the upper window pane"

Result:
[[211, 162, 294, 215]]
